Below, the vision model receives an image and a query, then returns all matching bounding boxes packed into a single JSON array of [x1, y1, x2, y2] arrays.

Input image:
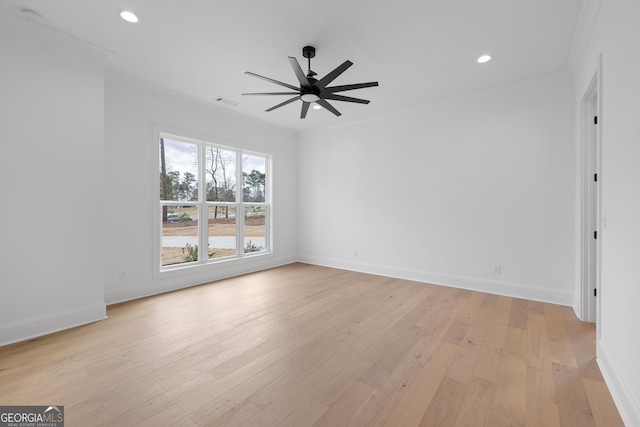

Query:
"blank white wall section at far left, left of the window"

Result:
[[0, 13, 105, 345]]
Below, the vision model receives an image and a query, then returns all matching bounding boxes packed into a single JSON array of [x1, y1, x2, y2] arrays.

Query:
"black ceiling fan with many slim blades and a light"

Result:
[[243, 46, 378, 119]]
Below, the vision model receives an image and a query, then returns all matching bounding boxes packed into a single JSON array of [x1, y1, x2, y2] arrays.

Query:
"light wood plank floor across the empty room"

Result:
[[0, 264, 622, 427]]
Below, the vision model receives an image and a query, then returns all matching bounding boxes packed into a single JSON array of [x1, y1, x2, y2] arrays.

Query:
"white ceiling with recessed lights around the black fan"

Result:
[[0, 0, 584, 130]]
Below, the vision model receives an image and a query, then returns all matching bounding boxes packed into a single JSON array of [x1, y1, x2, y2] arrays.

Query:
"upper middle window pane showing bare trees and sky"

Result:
[[204, 146, 236, 202]]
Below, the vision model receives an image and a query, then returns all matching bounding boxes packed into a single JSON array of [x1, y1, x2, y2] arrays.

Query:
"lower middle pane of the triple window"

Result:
[[208, 206, 236, 259]]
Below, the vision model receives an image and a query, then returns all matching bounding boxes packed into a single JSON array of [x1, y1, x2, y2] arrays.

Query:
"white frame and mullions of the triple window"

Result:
[[157, 129, 273, 273]]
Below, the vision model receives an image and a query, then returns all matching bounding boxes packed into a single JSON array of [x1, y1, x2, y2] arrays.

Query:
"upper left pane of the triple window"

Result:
[[160, 138, 198, 201]]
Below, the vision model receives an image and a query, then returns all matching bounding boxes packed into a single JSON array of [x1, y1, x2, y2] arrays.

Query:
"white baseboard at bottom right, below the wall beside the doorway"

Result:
[[596, 340, 640, 426]]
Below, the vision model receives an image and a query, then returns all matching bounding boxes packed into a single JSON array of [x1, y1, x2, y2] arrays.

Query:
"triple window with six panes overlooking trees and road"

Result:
[[158, 134, 270, 270]]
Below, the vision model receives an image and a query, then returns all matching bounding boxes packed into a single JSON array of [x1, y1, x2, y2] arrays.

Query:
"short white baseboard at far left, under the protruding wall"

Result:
[[0, 302, 107, 346]]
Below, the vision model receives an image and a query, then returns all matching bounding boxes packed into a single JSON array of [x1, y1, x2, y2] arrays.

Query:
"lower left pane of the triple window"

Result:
[[161, 205, 198, 266]]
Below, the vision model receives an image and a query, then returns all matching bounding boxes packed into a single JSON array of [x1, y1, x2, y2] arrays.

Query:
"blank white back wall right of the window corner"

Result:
[[298, 72, 575, 305]]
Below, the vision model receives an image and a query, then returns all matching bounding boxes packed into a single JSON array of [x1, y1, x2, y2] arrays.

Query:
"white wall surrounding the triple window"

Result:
[[104, 74, 297, 303]]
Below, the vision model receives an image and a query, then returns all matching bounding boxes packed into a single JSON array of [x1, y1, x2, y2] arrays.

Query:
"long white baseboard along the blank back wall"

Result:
[[298, 255, 573, 306]]
